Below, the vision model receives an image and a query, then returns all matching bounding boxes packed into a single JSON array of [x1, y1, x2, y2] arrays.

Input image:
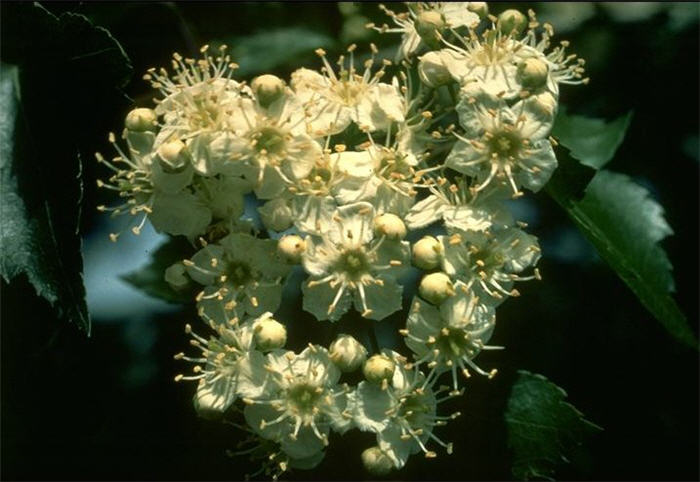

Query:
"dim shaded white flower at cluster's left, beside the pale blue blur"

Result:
[[183, 233, 291, 323]]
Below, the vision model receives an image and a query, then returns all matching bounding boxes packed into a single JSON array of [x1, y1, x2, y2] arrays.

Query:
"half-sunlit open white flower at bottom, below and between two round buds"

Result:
[[244, 345, 352, 458]]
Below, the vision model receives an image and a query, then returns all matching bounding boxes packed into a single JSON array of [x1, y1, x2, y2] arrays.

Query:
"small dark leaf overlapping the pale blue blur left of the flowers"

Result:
[[121, 238, 196, 303]]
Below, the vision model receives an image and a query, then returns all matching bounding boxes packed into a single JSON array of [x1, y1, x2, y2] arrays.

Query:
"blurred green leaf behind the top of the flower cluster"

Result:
[[221, 27, 335, 77]]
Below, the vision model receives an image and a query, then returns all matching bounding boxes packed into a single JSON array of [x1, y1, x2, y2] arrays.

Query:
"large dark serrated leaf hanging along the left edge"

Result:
[[0, 3, 131, 335]]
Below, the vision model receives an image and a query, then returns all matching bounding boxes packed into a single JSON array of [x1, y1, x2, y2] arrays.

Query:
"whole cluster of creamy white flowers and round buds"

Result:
[[97, 2, 587, 477]]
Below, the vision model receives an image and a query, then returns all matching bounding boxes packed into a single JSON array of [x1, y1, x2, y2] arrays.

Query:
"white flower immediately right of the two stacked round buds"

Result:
[[438, 228, 540, 307]]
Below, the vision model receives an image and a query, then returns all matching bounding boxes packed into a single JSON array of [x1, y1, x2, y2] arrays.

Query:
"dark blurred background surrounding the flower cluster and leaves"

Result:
[[1, 2, 700, 480]]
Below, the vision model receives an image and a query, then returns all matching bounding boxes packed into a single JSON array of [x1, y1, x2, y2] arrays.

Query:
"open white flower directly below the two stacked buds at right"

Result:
[[401, 292, 499, 390]]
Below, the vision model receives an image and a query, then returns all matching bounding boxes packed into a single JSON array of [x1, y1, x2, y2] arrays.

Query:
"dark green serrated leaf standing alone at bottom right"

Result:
[[505, 370, 602, 480]]
